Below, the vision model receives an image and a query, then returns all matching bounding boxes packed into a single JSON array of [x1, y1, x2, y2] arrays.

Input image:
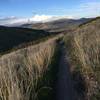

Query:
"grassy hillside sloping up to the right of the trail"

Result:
[[65, 17, 100, 100]]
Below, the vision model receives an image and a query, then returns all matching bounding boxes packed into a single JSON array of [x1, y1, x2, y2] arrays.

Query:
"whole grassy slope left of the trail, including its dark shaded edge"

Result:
[[0, 38, 59, 100]]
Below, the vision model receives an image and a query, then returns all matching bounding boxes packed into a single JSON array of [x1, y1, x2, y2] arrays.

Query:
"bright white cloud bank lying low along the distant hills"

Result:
[[0, 15, 73, 26]]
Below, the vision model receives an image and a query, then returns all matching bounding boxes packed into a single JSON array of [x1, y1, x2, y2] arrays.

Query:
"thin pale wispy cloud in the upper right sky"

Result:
[[52, 0, 100, 18]]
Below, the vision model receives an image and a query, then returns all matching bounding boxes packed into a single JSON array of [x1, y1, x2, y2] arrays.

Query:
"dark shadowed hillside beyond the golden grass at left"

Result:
[[0, 26, 50, 52]]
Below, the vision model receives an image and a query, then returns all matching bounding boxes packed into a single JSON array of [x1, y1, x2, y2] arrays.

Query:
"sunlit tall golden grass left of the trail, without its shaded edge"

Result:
[[0, 39, 56, 100]]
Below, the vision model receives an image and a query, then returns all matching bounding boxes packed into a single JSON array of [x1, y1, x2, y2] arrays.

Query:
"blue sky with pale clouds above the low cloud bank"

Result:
[[0, 0, 100, 25]]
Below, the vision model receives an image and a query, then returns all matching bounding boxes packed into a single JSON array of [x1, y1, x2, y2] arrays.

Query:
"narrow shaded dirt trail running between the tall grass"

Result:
[[56, 46, 77, 100]]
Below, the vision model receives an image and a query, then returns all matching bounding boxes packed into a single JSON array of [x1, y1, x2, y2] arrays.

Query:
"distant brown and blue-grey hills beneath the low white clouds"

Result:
[[21, 18, 91, 32]]
